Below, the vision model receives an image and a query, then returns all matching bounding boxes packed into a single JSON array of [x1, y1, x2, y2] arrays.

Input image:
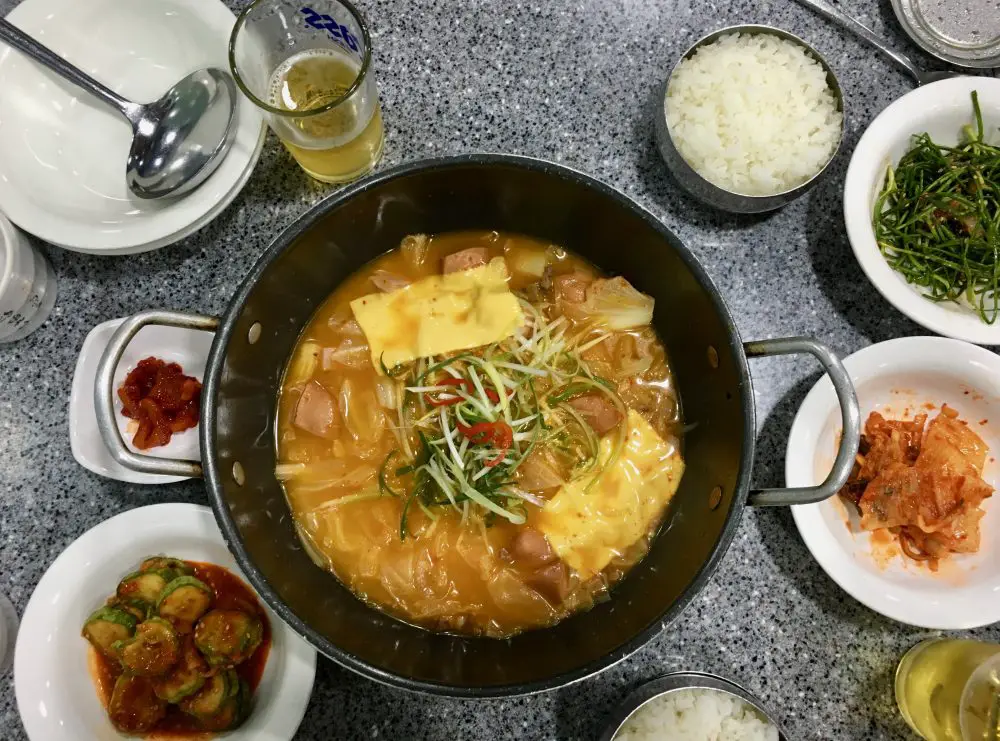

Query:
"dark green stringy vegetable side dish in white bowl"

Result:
[[872, 91, 1000, 324]]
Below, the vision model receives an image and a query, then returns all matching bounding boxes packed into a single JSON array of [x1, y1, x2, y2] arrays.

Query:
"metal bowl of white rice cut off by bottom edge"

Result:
[[601, 672, 787, 741]]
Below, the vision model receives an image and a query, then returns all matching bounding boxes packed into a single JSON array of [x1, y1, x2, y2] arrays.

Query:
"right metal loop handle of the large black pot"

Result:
[[743, 337, 861, 507]]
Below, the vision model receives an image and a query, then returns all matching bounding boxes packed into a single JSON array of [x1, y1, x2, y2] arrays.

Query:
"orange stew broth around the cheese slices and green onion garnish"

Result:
[[277, 232, 681, 637]]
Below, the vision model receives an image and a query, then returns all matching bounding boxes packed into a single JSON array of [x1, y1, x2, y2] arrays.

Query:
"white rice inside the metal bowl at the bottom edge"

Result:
[[614, 689, 778, 741]]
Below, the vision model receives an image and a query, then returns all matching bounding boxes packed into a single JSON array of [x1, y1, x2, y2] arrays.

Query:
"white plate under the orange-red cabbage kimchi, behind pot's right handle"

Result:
[[785, 337, 1000, 630]]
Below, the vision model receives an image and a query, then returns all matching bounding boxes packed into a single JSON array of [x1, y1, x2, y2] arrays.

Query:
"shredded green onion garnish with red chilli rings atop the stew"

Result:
[[368, 284, 627, 539]]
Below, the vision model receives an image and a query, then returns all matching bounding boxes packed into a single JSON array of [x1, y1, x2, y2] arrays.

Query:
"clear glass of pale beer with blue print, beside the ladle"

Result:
[[229, 0, 385, 183]]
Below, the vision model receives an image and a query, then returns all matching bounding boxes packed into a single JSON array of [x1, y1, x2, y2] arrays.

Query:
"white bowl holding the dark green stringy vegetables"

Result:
[[844, 77, 1000, 345]]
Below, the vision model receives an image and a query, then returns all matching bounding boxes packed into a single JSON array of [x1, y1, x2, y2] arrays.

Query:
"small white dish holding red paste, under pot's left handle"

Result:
[[69, 319, 214, 484]]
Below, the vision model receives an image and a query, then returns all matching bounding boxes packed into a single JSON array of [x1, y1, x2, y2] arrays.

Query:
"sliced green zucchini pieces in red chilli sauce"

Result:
[[82, 556, 270, 737]]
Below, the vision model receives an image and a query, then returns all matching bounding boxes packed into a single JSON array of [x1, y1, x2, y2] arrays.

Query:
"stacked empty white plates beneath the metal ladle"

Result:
[[0, 0, 265, 254]]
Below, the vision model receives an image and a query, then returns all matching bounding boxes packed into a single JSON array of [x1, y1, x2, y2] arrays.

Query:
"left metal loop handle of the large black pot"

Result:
[[94, 311, 219, 478]]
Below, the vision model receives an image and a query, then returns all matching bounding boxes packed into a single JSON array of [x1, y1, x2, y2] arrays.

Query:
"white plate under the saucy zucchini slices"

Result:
[[14, 504, 316, 741]]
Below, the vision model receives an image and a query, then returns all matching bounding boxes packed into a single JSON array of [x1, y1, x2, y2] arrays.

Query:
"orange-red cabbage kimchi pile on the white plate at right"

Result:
[[840, 405, 993, 571]]
